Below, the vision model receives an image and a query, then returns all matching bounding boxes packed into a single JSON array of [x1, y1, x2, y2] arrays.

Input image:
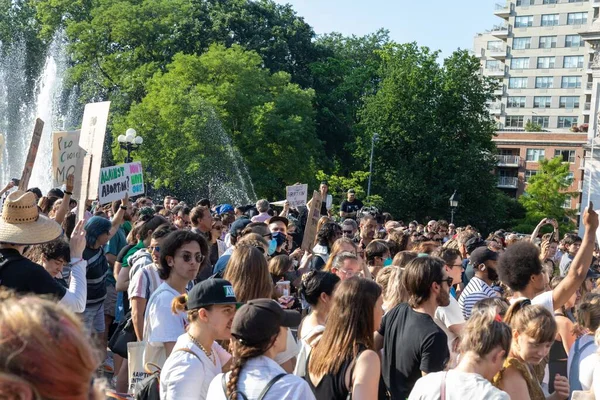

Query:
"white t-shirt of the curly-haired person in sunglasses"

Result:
[[144, 282, 187, 346]]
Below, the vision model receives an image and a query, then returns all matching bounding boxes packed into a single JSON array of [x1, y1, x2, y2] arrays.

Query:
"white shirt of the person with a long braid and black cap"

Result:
[[206, 356, 315, 400]]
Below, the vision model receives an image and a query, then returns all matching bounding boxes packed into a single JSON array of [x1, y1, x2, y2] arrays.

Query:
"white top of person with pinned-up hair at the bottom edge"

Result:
[[408, 370, 510, 400]]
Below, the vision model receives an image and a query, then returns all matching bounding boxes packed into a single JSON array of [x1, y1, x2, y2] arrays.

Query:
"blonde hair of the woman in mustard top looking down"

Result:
[[504, 299, 557, 344]]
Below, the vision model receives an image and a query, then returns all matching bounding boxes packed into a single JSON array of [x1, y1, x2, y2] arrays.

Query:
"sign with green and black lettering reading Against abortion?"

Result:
[[98, 162, 144, 204]]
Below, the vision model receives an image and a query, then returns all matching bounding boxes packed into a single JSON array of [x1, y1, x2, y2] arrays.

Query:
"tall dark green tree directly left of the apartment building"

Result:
[[357, 44, 497, 229]]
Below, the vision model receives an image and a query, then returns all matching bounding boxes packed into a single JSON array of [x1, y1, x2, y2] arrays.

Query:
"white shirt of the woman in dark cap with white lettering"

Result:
[[160, 333, 231, 400]]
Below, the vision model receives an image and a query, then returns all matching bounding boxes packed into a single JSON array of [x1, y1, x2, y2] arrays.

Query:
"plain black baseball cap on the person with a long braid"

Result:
[[231, 299, 302, 346]]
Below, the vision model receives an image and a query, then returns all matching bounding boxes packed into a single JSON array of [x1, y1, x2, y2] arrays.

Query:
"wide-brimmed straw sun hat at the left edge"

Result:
[[0, 190, 63, 244]]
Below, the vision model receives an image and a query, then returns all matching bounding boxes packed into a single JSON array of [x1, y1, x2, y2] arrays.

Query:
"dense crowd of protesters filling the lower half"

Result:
[[0, 182, 600, 400]]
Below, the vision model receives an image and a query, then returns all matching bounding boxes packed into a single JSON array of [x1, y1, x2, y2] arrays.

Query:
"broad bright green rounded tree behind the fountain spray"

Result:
[[115, 45, 320, 202]]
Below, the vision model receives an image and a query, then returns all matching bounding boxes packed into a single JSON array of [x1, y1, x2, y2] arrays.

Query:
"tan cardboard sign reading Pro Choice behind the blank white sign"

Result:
[[52, 130, 85, 199]]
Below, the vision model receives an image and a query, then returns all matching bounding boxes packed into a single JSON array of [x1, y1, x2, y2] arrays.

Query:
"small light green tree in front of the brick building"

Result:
[[515, 157, 577, 233]]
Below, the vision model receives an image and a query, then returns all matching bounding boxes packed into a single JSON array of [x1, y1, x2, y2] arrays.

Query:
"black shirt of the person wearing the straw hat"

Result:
[[0, 249, 67, 300]]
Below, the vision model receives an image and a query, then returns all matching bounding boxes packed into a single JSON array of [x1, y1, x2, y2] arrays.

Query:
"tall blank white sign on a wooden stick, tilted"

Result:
[[77, 101, 110, 219]]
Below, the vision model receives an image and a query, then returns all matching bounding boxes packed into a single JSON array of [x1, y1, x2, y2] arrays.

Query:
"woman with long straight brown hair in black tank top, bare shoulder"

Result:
[[306, 278, 383, 400]]
